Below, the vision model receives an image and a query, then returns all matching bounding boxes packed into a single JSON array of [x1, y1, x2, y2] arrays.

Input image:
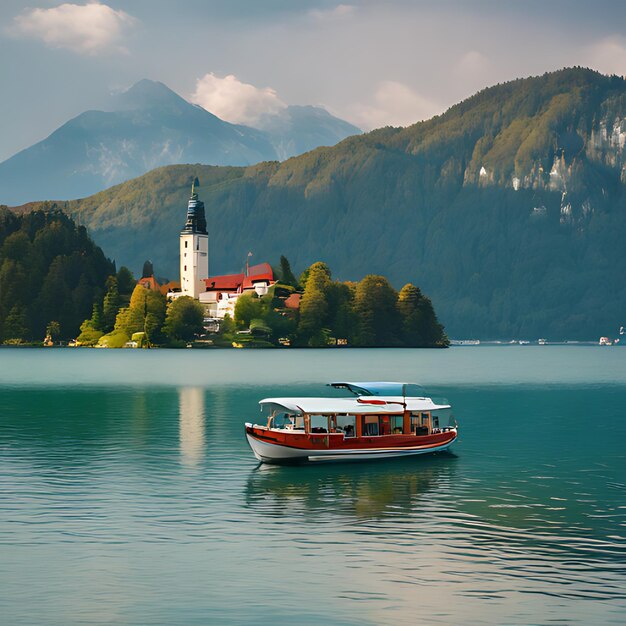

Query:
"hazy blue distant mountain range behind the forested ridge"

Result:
[[0, 80, 360, 204]]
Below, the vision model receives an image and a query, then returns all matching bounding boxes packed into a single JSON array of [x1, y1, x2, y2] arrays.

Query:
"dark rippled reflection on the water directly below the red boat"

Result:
[[246, 453, 456, 519]]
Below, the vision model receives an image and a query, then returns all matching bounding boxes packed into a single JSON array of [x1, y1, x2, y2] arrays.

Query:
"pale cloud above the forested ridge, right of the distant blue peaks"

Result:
[[347, 80, 441, 129]]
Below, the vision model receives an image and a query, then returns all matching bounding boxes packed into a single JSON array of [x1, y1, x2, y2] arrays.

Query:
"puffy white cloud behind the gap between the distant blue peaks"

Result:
[[191, 73, 287, 126]]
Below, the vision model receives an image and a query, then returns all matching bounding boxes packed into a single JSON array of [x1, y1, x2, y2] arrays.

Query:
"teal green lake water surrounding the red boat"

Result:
[[0, 346, 626, 625]]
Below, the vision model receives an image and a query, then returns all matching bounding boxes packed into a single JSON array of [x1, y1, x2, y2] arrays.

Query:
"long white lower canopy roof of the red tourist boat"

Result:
[[259, 395, 451, 415]]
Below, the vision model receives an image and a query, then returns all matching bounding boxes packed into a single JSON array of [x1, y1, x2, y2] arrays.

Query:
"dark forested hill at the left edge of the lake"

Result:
[[0, 207, 115, 343]]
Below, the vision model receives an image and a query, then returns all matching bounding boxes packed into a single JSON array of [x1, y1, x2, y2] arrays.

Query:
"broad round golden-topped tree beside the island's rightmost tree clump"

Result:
[[354, 274, 400, 346]]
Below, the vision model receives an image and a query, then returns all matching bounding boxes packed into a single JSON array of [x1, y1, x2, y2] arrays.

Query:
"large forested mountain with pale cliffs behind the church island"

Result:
[[12, 68, 626, 340]]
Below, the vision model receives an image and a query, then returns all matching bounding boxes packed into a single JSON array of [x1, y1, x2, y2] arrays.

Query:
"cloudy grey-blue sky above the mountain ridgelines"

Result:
[[0, 0, 626, 160]]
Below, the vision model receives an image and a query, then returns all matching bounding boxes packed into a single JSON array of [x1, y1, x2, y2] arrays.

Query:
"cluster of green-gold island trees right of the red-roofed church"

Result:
[[227, 256, 449, 348]]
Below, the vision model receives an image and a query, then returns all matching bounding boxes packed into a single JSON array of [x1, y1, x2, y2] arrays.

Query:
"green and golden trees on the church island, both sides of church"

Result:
[[77, 257, 449, 348]]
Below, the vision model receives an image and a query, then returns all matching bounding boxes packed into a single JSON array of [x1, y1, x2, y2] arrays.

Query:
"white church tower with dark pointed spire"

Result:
[[180, 178, 209, 300]]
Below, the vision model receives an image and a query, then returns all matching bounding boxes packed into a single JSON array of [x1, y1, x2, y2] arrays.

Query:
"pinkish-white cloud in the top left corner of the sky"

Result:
[[13, 2, 135, 54]]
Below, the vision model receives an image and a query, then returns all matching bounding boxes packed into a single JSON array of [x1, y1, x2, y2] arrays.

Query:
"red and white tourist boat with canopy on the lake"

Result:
[[245, 382, 457, 464]]
